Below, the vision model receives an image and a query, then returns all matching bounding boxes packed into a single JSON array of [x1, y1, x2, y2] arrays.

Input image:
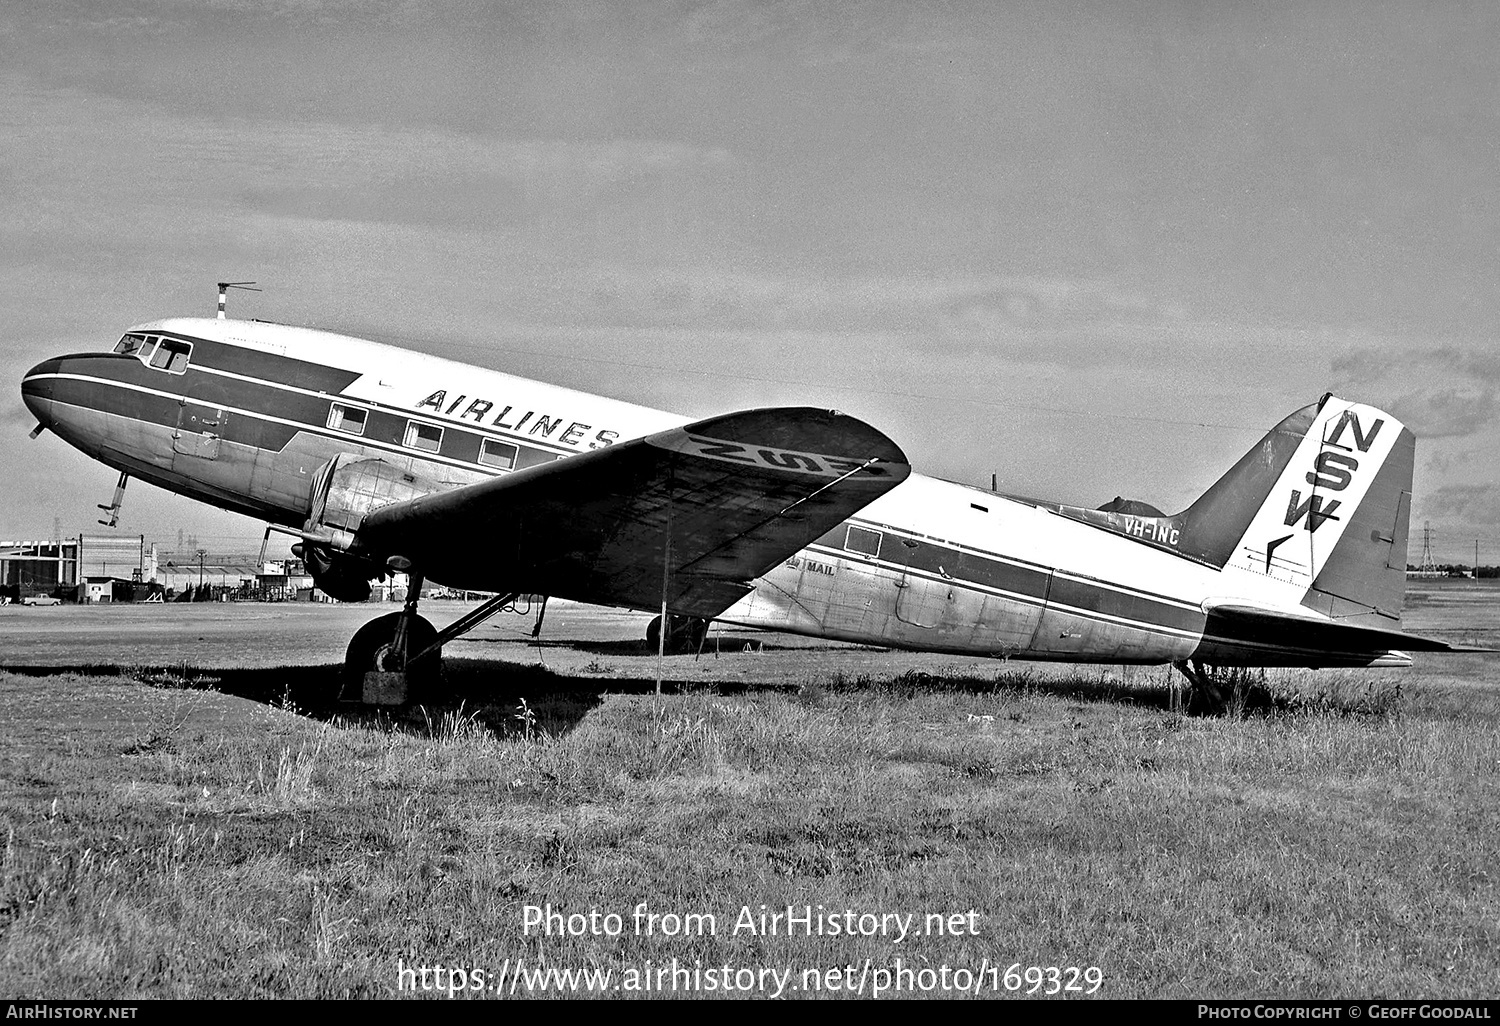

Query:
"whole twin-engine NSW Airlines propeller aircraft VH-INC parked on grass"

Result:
[[21, 318, 1446, 701]]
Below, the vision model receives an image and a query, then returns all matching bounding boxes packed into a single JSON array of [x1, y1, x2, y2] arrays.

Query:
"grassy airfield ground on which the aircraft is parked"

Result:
[[0, 585, 1500, 998]]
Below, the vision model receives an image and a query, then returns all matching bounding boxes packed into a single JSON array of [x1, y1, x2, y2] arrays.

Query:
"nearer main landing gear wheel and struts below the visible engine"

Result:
[[339, 572, 518, 705]]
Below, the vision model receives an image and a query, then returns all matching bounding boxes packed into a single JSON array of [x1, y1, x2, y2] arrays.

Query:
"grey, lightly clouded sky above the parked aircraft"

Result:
[[0, 0, 1500, 564]]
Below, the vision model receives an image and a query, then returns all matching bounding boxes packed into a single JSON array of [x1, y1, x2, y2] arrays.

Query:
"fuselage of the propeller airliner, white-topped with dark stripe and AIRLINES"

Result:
[[23, 318, 1404, 666]]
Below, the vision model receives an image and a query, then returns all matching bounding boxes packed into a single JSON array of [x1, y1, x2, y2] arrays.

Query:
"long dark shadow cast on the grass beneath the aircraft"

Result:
[[0, 654, 1188, 738]]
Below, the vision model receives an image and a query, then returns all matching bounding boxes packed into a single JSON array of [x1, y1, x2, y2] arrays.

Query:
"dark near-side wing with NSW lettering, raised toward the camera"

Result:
[[357, 408, 911, 617]]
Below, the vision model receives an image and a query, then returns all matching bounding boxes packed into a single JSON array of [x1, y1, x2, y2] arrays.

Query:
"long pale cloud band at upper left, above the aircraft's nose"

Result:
[[0, 72, 740, 273]]
